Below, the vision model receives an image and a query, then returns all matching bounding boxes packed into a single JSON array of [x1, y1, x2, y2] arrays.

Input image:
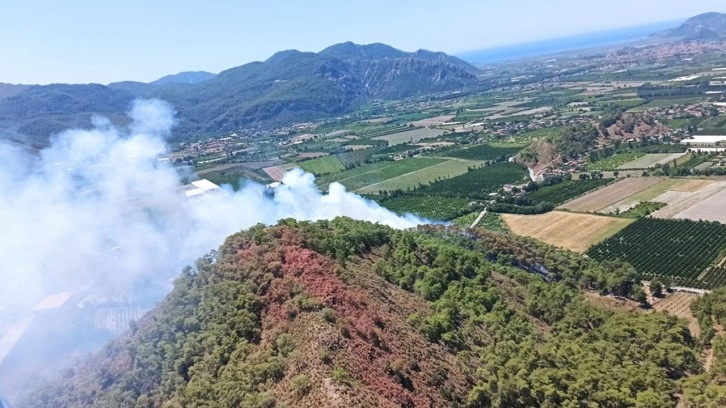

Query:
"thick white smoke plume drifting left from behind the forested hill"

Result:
[[0, 101, 421, 309]]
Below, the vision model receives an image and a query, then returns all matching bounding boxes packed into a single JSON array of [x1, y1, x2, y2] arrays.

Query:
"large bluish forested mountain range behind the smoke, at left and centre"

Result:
[[0, 42, 479, 147]]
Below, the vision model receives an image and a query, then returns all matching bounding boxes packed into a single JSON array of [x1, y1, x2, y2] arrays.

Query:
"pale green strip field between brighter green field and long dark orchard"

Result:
[[358, 159, 481, 194]]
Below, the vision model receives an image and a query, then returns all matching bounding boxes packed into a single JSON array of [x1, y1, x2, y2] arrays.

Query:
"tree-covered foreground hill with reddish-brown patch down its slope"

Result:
[[23, 218, 726, 408]]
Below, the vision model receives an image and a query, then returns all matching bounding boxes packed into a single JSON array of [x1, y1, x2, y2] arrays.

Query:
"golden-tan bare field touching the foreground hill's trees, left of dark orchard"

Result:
[[501, 211, 632, 252]]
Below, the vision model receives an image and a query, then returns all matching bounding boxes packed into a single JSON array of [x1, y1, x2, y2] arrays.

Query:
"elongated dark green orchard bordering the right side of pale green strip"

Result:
[[417, 162, 528, 198]]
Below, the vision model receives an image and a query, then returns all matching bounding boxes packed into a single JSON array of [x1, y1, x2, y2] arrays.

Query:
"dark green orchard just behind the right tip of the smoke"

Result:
[[379, 196, 476, 221]]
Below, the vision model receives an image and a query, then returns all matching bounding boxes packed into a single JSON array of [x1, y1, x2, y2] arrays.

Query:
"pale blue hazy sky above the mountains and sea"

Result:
[[0, 0, 726, 83]]
